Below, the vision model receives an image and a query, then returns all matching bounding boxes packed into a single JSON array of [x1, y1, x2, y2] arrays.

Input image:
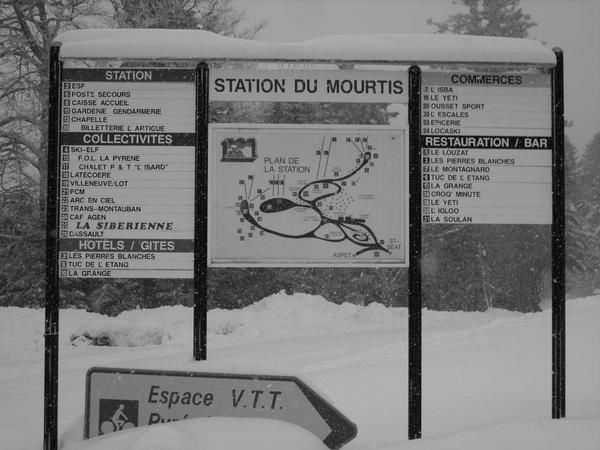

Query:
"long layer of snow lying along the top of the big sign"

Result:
[[57, 29, 556, 65]]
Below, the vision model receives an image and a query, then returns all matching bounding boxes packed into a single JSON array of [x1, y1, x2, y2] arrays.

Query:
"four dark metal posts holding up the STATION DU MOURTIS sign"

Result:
[[43, 38, 566, 450]]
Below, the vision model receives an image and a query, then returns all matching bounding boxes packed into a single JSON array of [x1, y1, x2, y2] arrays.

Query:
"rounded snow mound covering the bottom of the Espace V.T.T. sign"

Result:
[[62, 417, 328, 450]]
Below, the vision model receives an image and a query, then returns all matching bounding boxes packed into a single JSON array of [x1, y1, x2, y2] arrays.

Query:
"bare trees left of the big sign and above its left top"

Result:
[[0, 0, 265, 305]]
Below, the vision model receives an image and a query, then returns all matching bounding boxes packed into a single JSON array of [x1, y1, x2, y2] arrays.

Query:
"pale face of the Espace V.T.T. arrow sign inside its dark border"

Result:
[[88, 371, 331, 439]]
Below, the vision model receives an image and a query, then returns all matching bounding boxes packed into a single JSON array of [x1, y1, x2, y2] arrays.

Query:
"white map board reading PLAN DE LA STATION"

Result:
[[209, 124, 408, 266]]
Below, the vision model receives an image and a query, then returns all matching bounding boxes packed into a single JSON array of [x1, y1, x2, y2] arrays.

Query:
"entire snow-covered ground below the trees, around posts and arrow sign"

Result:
[[0, 294, 600, 450]]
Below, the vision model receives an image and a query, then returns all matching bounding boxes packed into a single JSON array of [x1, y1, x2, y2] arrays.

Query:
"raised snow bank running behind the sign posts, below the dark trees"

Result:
[[0, 291, 572, 361]]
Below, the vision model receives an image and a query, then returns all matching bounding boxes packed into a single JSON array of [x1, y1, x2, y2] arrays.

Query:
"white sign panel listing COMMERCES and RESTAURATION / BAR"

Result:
[[421, 72, 553, 224]]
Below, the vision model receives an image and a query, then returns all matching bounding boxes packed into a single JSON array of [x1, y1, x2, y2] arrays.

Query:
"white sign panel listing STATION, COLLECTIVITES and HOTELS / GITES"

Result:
[[59, 68, 196, 278]]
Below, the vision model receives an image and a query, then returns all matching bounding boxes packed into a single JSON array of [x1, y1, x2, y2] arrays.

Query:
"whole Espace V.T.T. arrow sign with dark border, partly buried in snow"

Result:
[[84, 367, 357, 449]]
